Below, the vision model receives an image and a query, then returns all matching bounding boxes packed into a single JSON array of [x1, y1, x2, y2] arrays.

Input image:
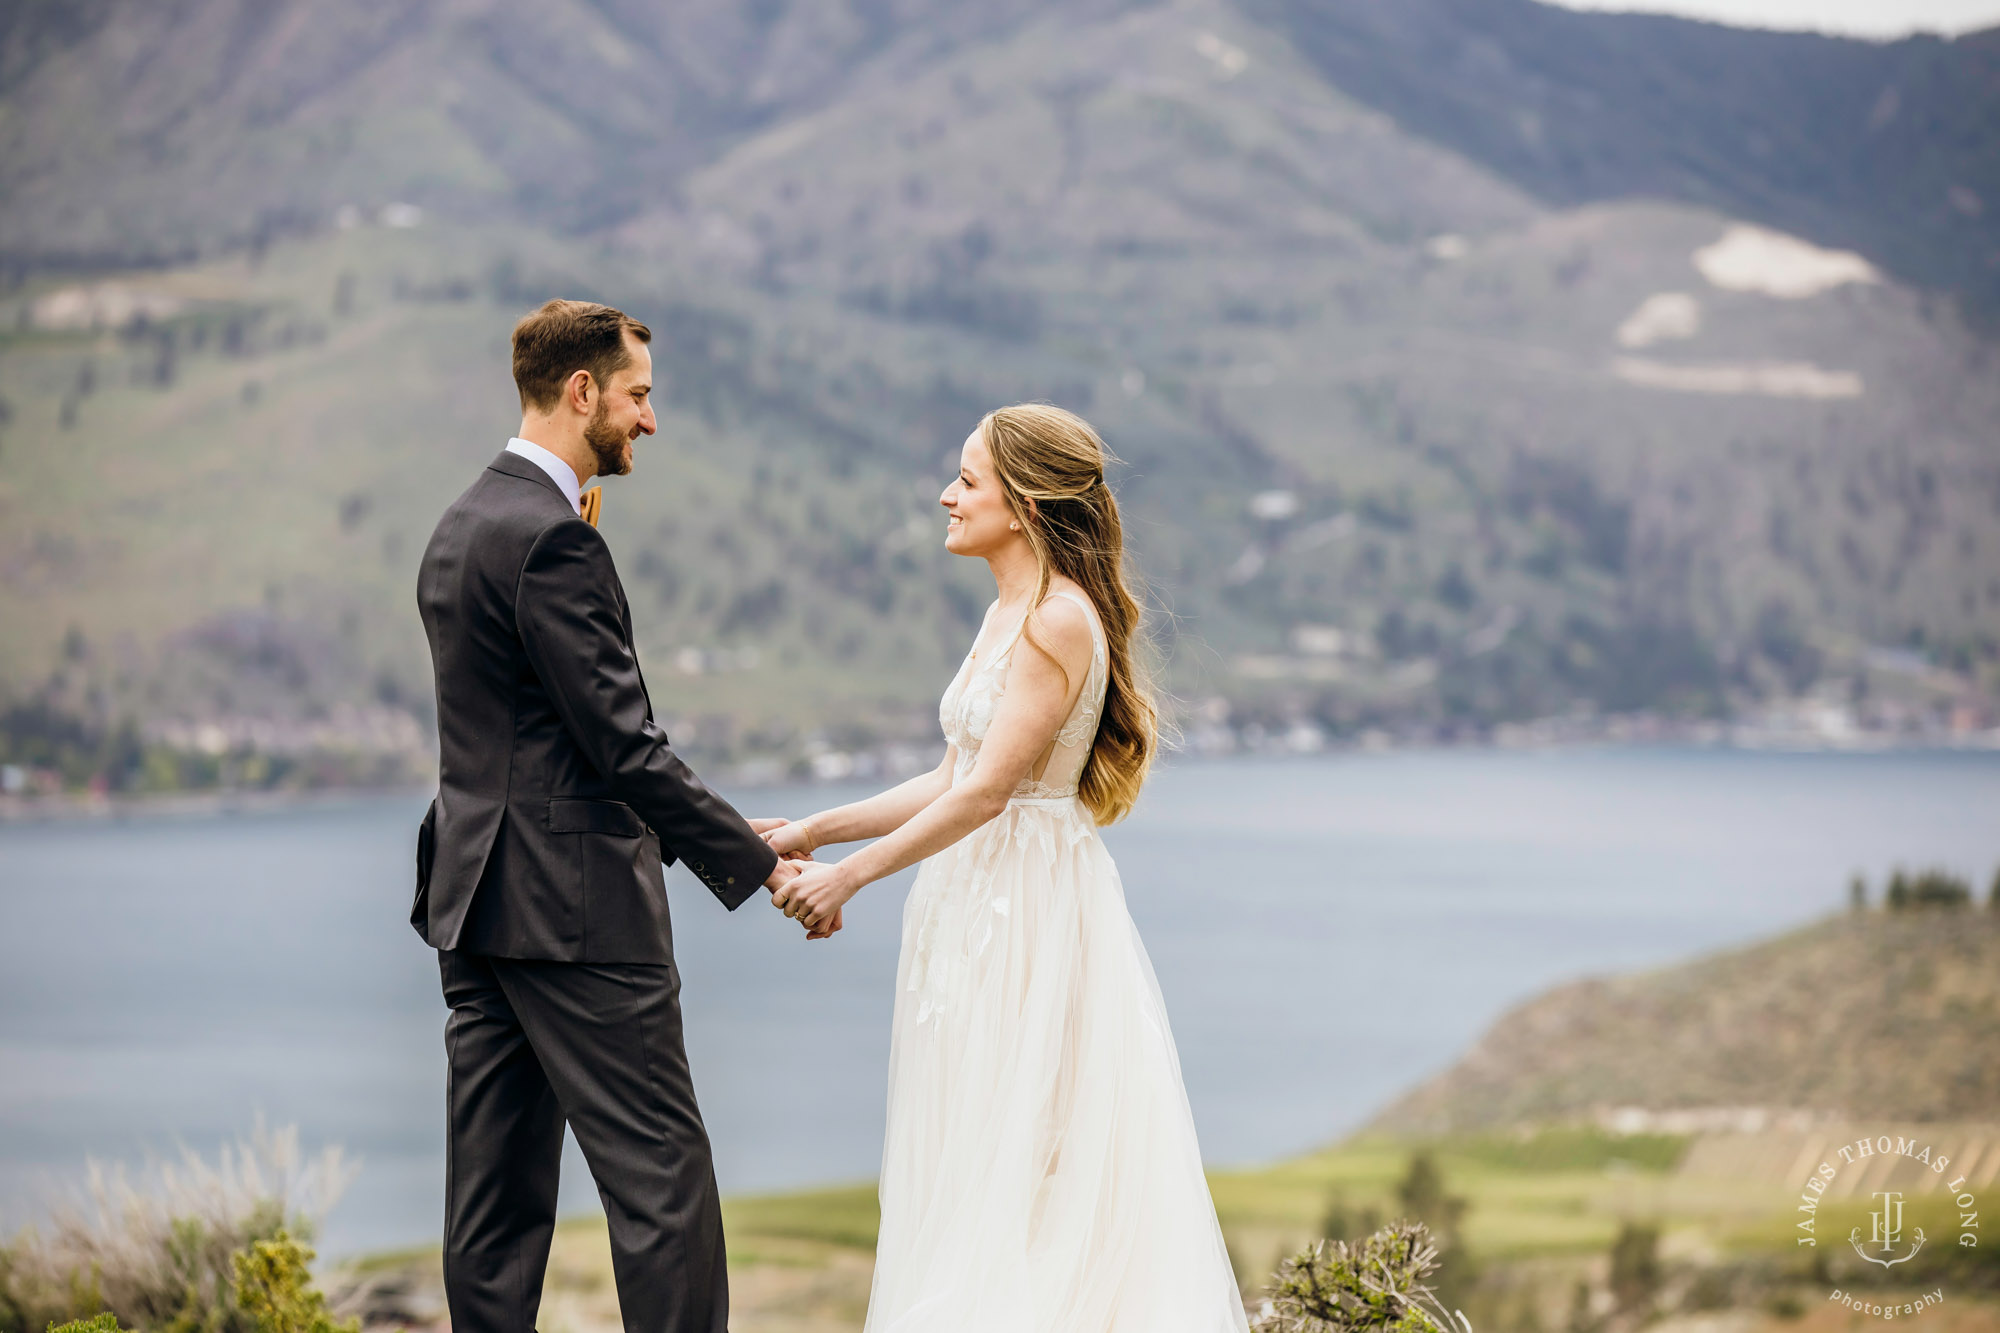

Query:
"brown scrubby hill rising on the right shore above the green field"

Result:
[[1374, 896, 2000, 1133]]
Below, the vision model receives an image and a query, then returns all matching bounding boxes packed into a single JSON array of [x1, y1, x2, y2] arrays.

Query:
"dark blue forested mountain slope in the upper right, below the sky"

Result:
[[1246, 0, 2000, 318]]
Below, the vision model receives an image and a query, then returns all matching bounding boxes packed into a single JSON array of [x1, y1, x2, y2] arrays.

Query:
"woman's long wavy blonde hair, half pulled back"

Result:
[[980, 402, 1160, 825]]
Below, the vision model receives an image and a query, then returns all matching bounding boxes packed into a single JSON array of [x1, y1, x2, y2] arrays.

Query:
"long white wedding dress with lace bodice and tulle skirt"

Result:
[[866, 592, 1246, 1333]]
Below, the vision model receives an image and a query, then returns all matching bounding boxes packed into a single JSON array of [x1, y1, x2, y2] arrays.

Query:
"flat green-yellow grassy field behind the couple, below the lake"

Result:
[[360, 1127, 2000, 1333]]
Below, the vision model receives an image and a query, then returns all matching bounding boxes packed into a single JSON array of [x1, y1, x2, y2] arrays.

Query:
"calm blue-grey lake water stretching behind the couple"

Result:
[[0, 749, 2000, 1255]]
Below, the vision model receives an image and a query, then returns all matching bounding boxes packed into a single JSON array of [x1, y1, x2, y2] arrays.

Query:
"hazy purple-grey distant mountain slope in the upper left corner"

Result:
[[0, 0, 1080, 266]]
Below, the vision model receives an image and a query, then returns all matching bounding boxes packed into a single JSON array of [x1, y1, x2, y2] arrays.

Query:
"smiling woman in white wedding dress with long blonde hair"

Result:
[[764, 404, 1246, 1333]]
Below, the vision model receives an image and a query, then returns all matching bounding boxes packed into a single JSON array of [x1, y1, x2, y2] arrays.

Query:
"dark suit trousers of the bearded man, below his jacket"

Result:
[[438, 951, 730, 1333]]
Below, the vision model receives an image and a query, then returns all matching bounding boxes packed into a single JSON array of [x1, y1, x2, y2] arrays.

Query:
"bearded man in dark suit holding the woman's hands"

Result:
[[410, 300, 812, 1333]]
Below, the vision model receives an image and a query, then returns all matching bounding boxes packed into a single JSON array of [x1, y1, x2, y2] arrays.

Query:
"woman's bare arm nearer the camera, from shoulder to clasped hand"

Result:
[[772, 598, 1092, 927]]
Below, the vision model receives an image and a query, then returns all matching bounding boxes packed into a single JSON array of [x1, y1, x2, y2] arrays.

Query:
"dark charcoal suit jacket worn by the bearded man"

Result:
[[410, 452, 778, 963]]
